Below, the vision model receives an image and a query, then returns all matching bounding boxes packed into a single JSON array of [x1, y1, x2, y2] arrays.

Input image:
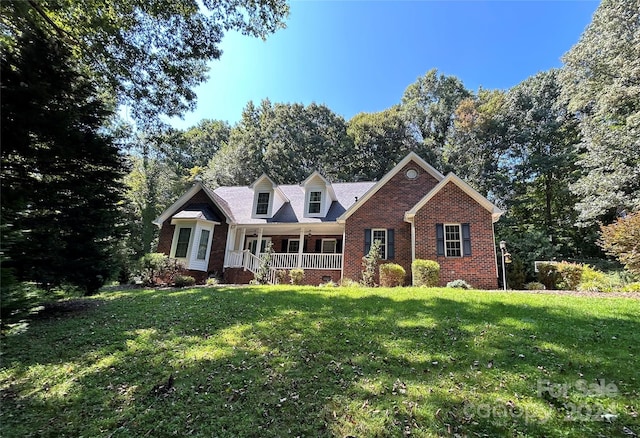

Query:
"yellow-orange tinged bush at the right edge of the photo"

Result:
[[598, 211, 640, 275]]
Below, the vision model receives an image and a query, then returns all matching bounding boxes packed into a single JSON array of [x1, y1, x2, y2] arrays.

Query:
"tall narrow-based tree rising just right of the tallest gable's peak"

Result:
[[401, 69, 471, 170]]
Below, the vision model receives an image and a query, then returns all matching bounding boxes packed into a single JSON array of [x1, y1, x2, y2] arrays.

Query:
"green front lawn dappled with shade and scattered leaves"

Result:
[[0, 286, 640, 437]]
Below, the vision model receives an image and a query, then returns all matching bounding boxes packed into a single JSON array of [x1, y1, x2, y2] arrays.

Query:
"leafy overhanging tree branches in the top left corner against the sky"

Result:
[[0, 0, 288, 122]]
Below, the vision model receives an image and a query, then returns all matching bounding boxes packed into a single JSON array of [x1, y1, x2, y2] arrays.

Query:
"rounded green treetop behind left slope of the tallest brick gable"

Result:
[[343, 106, 418, 181]]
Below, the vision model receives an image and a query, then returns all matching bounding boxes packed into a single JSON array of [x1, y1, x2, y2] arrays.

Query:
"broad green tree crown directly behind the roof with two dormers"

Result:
[[204, 99, 351, 186]]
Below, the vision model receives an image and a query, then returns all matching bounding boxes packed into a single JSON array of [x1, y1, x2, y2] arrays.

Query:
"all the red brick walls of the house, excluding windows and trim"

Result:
[[158, 158, 498, 289]]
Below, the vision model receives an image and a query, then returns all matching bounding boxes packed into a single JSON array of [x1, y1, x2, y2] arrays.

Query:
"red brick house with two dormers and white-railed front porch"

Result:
[[155, 153, 502, 289]]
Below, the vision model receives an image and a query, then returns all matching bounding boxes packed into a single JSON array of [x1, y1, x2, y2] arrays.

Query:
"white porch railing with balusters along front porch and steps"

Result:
[[226, 250, 342, 272]]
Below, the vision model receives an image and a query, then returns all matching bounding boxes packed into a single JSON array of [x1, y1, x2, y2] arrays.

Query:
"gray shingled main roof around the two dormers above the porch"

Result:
[[213, 182, 376, 224]]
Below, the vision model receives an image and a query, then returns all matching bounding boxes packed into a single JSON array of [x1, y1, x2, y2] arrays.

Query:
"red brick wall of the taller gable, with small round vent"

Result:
[[344, 162, 438, 285]]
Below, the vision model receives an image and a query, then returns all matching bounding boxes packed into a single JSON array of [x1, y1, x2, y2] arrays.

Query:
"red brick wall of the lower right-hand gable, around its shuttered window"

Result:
[[414, 182, 498, 289]]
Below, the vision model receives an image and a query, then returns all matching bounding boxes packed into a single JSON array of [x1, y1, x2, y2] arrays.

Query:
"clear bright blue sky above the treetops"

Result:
[[171, 0, 599, 129]]
